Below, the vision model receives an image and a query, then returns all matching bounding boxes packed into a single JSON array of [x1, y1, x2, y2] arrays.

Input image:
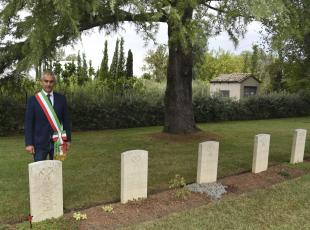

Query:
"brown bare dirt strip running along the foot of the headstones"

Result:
[[75, 165, 305, 229]]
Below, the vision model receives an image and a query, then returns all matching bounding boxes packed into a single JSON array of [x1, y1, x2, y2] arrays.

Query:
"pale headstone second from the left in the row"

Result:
[[121, 150, 148, 203]]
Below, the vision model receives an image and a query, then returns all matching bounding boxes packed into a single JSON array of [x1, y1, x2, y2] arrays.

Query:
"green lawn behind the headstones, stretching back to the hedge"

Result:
[[0, 117, 310, 223]]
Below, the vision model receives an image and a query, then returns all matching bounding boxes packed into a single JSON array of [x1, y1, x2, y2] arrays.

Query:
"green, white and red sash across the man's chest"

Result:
[[35, 91, 67, 155]]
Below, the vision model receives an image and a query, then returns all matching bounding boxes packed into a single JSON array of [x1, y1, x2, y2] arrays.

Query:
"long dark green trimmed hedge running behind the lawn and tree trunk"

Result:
[[0, 89, 310, 135]]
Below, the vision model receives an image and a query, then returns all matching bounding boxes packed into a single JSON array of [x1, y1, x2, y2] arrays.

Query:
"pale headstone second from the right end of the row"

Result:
[[252, 134, 270, 173]]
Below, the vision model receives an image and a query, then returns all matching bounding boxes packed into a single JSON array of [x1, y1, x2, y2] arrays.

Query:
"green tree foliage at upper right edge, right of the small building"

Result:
[[263, 0, 310, 92]]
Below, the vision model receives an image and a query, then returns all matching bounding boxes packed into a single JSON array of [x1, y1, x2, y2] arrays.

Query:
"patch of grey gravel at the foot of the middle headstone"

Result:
[[186, 182, 227, 200]]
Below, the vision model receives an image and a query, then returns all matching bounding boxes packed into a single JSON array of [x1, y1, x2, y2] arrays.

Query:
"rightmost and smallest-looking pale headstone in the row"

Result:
[[291, 129, 307, 164]]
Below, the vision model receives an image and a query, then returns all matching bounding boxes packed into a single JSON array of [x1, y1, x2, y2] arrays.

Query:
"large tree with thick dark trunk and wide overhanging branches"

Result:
[[0, 0, 282, 133]]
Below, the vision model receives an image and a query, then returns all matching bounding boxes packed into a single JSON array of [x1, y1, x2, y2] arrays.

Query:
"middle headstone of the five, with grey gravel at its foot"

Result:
[[197, 141, 219, 184]]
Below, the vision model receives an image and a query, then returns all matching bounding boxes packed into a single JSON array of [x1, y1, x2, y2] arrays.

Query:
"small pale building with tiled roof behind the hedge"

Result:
[[210, 73, 260, 100]]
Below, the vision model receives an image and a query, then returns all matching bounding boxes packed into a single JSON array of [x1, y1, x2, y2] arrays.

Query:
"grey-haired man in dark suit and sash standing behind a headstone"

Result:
[[25, 71, 71, 161]]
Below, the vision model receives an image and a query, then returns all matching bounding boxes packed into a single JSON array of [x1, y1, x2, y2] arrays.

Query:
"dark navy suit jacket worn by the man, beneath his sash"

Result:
[[25, 92, 71, 148]]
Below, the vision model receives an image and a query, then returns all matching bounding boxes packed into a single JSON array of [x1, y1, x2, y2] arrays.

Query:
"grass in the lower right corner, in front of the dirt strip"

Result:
[[129, 163, 310, 230]]
